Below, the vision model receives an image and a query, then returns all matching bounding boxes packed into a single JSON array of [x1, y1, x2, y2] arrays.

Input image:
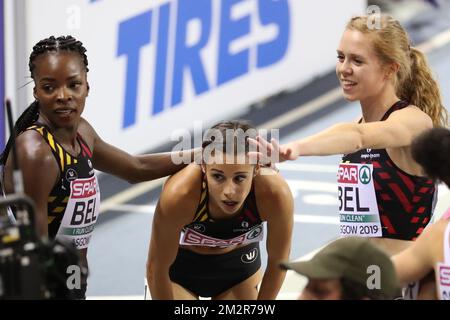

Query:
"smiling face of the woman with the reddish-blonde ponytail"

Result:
[[336, 29, 392, 101]]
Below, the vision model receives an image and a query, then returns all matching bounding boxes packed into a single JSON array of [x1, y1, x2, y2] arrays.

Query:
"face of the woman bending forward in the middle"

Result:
[[203, 155, 255, 217]]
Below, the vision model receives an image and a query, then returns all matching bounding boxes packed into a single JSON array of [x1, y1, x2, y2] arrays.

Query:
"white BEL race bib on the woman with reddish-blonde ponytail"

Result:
[[338, 163, 383, 237]]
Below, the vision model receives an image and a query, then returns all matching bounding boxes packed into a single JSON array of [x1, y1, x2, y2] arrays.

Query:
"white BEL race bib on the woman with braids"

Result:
[[56, 176, 100, 249]]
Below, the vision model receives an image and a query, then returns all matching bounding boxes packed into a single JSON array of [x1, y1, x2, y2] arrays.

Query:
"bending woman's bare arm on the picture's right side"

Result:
[[255, 174, 294, 300]]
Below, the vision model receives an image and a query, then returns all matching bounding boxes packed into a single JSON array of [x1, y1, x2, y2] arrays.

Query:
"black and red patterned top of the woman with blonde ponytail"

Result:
[[342, 101, 436, 240]]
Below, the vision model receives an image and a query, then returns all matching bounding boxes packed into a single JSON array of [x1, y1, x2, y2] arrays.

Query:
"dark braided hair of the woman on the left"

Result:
[[0, 36, 89, 165]]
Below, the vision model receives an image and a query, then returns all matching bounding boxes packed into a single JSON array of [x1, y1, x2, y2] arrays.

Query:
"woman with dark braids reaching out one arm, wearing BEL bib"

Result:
[[0, 36, 192, 298]]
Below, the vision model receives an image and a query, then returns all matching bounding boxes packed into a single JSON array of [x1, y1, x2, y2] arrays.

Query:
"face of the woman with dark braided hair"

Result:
[[33, 51, 89, 129]]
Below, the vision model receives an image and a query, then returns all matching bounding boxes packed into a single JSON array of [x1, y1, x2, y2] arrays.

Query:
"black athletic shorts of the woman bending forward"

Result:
[[169, 242, 261, 297]]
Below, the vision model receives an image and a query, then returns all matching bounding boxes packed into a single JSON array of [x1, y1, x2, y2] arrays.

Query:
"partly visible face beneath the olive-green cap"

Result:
[[298, 279, 342, 300]]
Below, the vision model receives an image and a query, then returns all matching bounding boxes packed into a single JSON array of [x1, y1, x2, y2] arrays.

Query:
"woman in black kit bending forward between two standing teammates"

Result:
[[147, 121, 293, 299]]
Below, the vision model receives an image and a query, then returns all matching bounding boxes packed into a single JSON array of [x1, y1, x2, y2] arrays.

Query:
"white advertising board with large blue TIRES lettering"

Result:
[[16, 0, 366, 153]]
